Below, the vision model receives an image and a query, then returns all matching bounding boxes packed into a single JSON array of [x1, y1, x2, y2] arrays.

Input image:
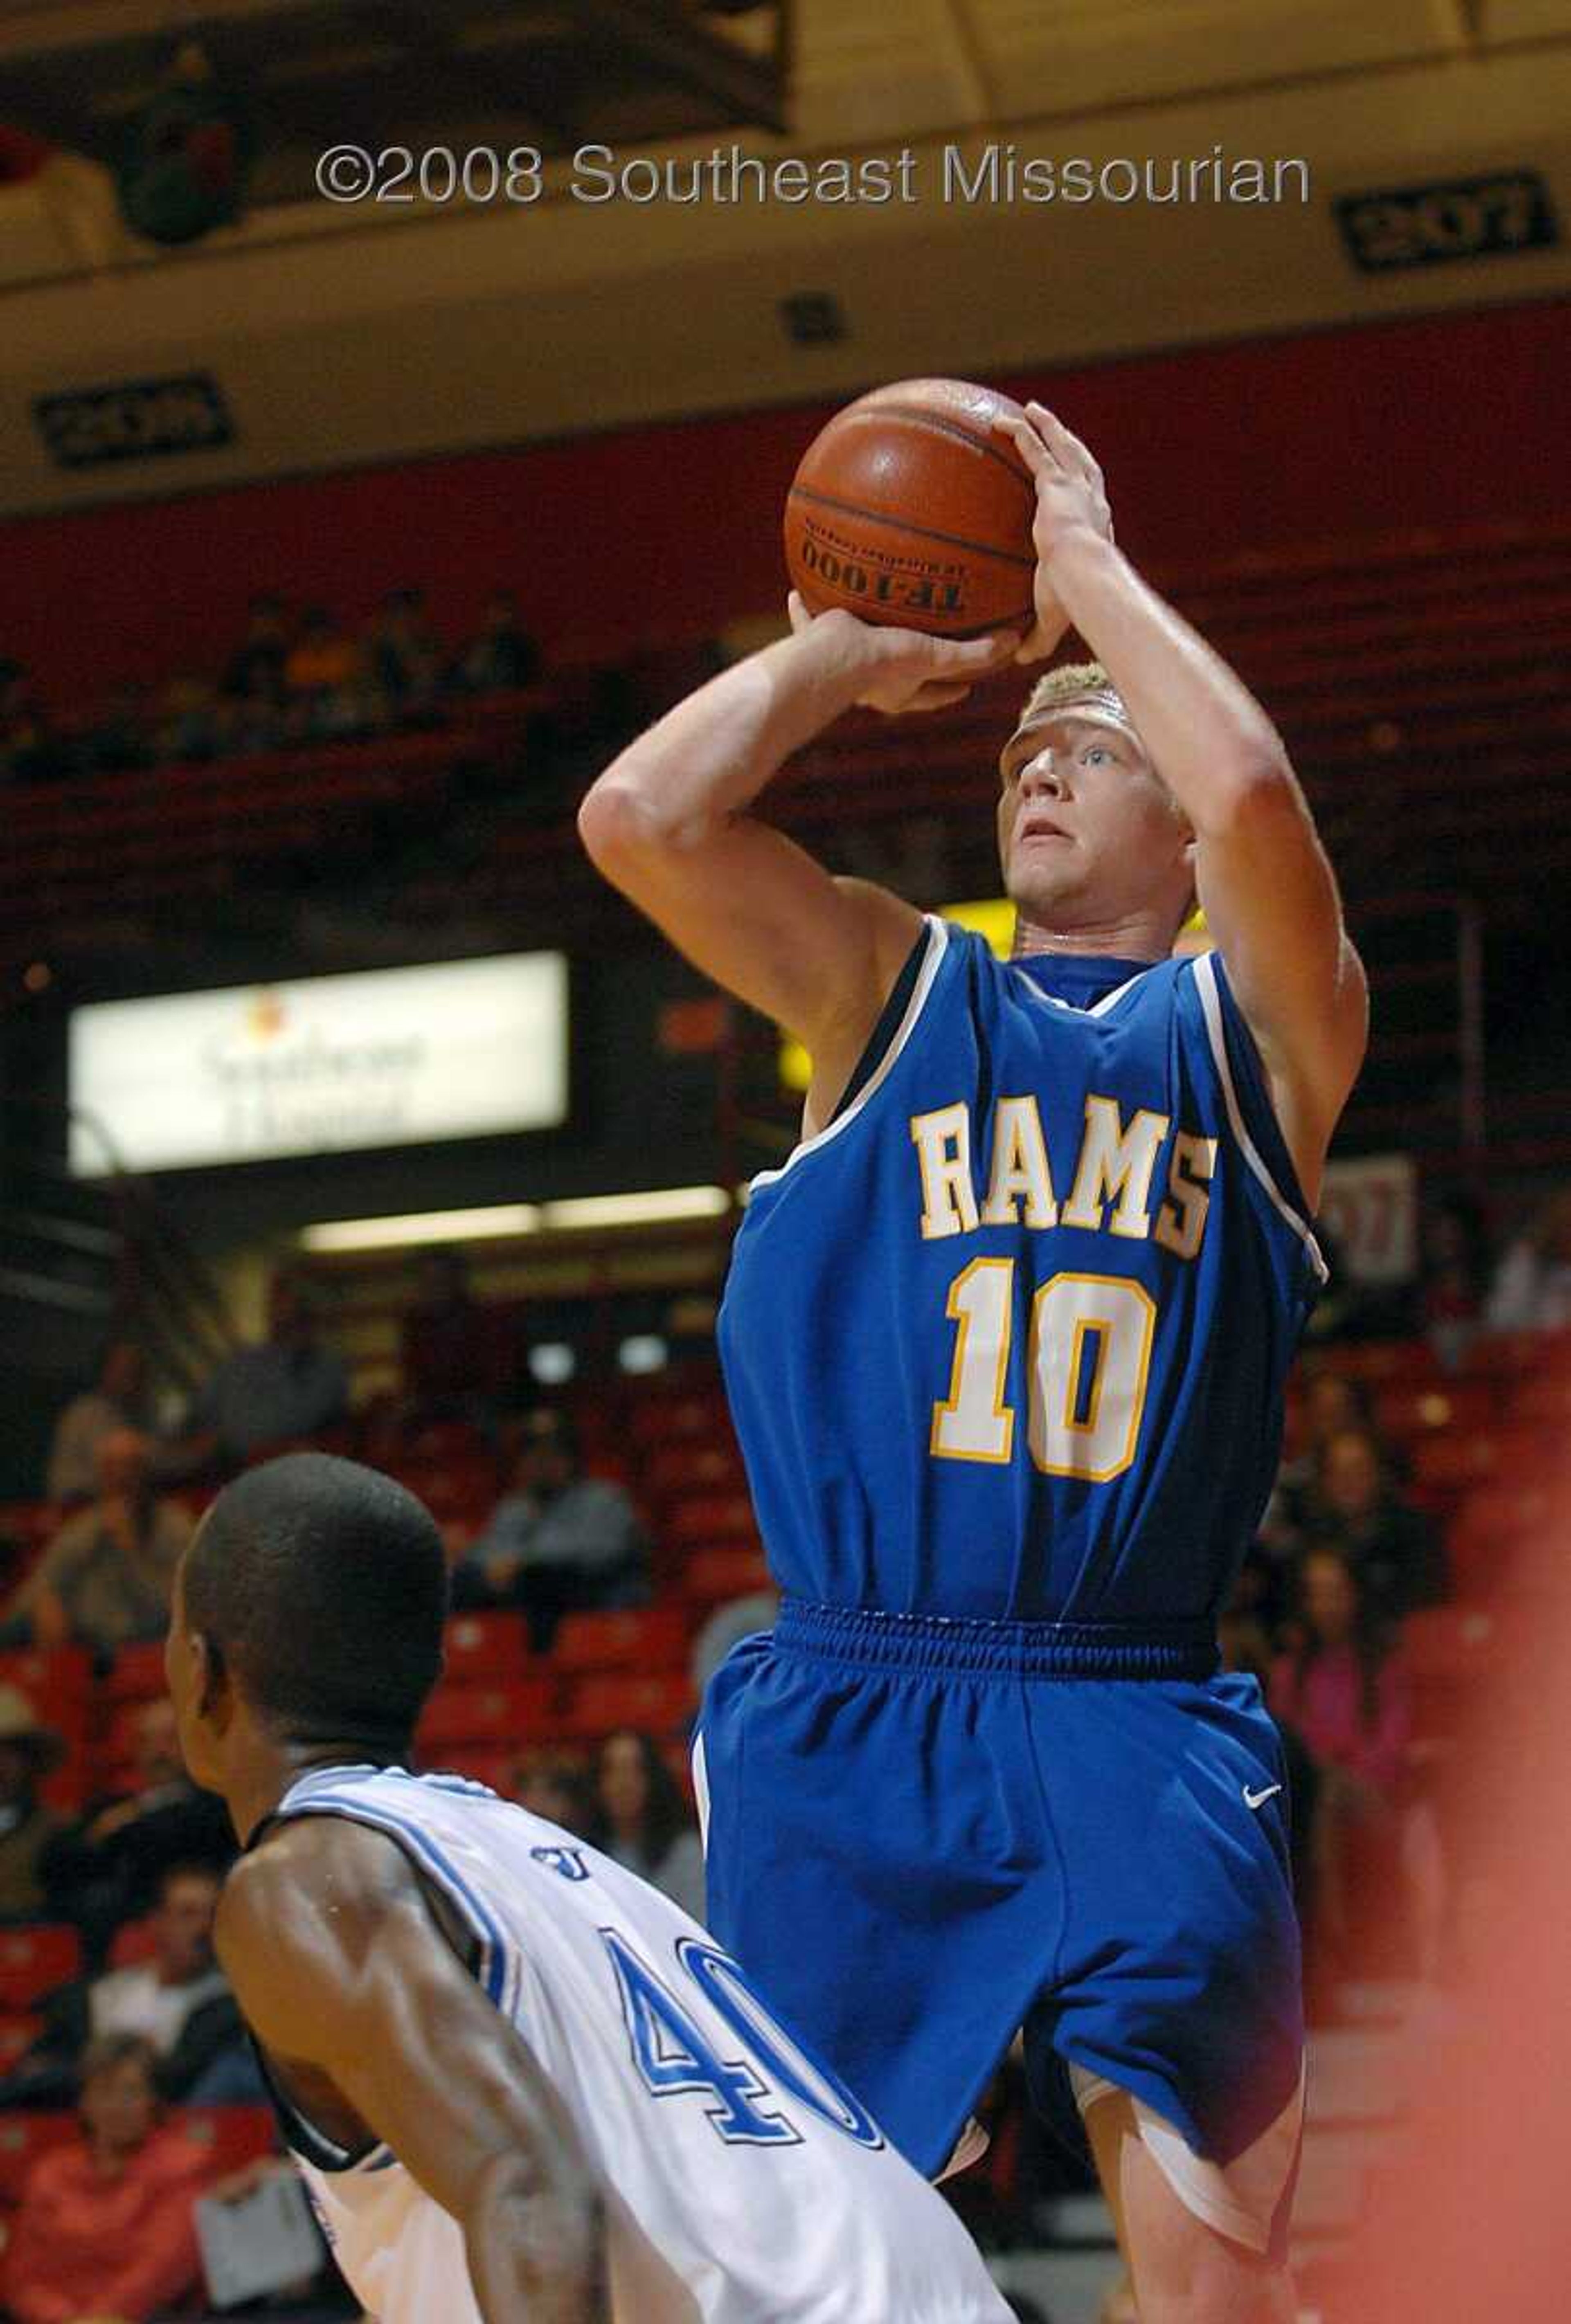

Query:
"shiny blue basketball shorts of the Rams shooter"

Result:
[[700, 1599, 1304, 2247]]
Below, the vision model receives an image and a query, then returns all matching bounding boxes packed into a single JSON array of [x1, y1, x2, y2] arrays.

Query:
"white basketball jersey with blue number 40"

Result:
[[267, 1766, 1011, 2324]]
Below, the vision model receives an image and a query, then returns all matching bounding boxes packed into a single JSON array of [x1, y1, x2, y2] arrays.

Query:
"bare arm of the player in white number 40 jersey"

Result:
[[216, 1820, 609, 2324]]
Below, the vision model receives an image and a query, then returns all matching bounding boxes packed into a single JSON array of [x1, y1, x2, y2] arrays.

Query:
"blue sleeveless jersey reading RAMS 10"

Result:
[[720, 918, 1325, 1622]]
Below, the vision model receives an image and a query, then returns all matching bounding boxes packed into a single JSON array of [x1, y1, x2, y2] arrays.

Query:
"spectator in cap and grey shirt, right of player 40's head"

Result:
[[453, 1406, 648, 1655]]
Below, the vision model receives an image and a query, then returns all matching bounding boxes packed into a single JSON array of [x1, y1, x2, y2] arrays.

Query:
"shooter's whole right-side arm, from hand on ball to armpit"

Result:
[[1008, 405, 1369, 1202]]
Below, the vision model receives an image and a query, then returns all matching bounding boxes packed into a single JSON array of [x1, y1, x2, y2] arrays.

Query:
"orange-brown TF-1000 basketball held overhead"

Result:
[[786, 379, 1036, 637]]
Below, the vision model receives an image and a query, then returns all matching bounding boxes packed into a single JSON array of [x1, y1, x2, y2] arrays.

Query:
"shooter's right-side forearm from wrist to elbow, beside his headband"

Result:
[[1051, 530, 1297, 837]]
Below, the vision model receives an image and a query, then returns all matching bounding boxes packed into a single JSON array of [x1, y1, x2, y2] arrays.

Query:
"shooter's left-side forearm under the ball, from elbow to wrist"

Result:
[[578, 616, 867, 860]]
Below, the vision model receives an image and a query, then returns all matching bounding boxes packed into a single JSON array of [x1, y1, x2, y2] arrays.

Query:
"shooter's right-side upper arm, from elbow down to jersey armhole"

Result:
[[1195, 767, 1369, 1204]]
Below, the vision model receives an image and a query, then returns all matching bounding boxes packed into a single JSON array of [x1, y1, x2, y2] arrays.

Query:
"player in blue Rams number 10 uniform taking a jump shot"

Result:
[[581, 405, 1366, 2324]]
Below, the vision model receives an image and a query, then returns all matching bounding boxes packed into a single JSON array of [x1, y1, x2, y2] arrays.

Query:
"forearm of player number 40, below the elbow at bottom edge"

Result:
[[465, 2157, 611, 2324]]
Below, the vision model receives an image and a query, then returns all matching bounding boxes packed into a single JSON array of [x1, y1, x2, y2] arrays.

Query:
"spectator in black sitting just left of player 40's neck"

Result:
[[44, 1697, 235, 1966]]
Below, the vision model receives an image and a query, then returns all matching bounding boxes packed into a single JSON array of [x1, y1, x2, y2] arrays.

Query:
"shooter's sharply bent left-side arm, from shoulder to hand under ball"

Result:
[[578, 607, 1015, 1095]]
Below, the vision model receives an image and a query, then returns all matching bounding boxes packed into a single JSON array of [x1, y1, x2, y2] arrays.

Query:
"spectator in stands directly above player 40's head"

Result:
[[174, 1267, 349, 1471]]
